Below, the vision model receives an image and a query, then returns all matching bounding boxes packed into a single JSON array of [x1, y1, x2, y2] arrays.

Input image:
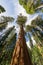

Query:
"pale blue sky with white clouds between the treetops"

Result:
[[0, 0, 42, 46]]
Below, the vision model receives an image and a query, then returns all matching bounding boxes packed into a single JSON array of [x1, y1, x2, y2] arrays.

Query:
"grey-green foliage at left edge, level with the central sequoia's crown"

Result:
[[0, 16, 14, 31]]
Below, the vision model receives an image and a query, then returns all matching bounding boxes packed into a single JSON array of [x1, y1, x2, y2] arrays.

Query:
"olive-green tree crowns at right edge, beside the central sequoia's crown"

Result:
[[26, 16, 43, 46]]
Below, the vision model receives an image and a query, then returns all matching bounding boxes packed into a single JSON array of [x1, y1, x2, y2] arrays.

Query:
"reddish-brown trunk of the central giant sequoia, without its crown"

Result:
[[10, 26, 32, 65]]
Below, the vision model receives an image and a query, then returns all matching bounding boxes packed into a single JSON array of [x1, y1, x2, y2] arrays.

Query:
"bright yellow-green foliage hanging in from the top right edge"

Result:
[[19, 0, 42, 14]]
